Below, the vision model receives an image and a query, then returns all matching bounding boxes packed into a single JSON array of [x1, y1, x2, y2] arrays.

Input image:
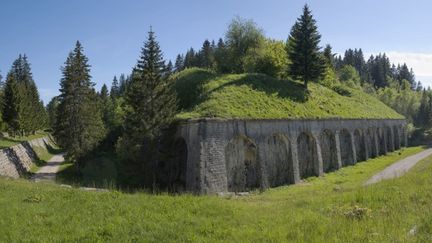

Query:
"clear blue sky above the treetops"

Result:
[[0, 0, 432, 104]]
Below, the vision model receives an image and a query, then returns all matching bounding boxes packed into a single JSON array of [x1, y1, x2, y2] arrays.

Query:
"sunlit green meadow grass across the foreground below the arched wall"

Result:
[[0, 147, 432, 242]]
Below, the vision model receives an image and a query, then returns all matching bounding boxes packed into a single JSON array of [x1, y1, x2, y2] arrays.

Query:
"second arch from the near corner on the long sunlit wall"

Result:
[[263, 134, 294, 187]]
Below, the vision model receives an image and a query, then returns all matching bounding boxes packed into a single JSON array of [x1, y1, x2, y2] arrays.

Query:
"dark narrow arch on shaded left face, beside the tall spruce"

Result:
[[171, 138, 188, 191]]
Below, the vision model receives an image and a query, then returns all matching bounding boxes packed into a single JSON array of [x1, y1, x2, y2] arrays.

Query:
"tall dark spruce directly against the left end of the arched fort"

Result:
[[117, 29, 176, 186]]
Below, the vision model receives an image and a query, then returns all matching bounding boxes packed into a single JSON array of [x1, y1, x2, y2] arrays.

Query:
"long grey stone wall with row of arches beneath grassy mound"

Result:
[[177, 119, 407, 193]]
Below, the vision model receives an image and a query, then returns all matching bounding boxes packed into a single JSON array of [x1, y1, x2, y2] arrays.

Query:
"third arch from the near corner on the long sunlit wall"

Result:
[[297, 132, 319, 178]]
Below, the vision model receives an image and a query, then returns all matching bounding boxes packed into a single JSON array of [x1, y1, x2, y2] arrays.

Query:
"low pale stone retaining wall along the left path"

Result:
[[0, 137, 52, 178]]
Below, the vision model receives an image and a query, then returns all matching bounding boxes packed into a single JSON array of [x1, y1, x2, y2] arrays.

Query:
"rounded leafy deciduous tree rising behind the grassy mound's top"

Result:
[[225, 17, 265, 73]]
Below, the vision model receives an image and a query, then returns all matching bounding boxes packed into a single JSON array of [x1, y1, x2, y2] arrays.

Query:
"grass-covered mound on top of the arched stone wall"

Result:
[[174, 68, 403, 119]]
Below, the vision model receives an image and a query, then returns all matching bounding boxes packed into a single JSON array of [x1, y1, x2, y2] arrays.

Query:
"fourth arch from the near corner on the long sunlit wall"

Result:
[[320, 129, 339, 172]]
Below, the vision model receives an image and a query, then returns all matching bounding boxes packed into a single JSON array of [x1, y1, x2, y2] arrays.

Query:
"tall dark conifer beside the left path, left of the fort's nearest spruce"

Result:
[[54, 41, 105, 163]]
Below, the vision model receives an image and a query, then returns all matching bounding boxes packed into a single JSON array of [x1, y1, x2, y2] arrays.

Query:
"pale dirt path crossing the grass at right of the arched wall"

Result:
[[365, 148, 432, 185]]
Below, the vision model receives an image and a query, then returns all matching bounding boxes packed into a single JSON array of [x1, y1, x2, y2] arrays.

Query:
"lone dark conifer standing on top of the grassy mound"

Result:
[[287, 5, 325, 89]]
